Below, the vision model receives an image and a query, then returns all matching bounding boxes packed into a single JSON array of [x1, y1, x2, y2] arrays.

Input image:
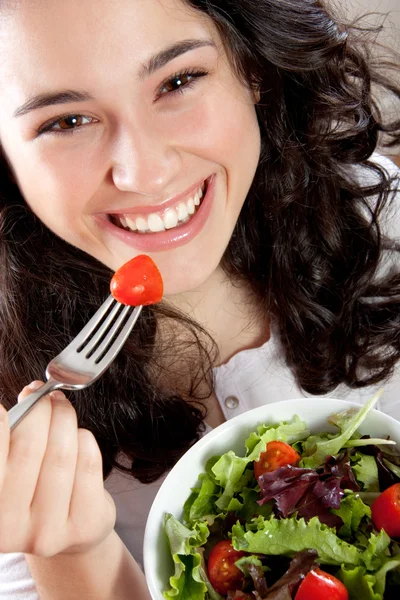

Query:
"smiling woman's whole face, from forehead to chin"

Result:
[[0, 0, 260, 294]]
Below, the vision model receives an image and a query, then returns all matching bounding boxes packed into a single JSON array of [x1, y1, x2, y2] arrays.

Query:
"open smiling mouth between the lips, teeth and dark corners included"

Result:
[[108, 179, 208, 234]]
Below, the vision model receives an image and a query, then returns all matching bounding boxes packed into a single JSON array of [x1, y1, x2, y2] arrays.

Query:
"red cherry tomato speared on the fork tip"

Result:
[[110, 254, 164, 306]]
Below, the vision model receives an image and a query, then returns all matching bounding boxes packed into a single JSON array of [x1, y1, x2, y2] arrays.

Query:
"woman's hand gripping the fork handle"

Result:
[[0, 382, 115, 557]]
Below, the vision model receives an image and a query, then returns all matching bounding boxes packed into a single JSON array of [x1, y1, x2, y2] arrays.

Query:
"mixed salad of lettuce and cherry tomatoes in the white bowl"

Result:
[[164, 393, 400, 600]]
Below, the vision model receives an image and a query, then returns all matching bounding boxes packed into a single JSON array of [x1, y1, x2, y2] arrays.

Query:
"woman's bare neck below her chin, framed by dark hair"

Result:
[[164, 267, 270, 364]]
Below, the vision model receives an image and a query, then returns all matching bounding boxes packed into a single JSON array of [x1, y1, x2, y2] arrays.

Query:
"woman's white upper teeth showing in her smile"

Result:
[[112, 182, 204, 233]]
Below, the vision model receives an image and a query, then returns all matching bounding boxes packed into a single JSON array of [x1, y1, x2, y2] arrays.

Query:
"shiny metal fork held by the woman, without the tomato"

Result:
[[8, 296, 142, 429]]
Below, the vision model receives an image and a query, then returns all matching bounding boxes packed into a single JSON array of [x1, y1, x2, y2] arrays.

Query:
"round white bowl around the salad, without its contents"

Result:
[[144, 397, 400, 600]]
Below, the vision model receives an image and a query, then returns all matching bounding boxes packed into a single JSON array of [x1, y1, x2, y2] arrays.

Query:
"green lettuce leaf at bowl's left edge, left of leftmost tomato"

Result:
[[164, 514, 209, 600]]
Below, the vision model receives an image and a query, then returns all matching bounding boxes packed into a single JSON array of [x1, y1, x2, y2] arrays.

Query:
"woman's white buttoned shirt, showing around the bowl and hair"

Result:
[[0, 157, 400, 600]]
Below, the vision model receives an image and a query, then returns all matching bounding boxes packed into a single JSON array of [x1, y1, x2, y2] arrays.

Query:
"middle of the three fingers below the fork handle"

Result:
[[31, 391, 78, 537]]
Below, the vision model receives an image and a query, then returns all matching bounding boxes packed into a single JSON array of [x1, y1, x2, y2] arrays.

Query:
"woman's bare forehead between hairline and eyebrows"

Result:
[[0, 0, 217, 101]]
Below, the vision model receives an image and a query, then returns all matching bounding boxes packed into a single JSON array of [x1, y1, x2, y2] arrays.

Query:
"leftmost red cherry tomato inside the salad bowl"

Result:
[[208, 540, 245, 596]]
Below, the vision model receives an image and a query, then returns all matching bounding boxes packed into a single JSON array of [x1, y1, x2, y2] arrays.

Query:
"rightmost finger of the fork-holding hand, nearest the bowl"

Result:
[[69, 429, 115, 546]]
